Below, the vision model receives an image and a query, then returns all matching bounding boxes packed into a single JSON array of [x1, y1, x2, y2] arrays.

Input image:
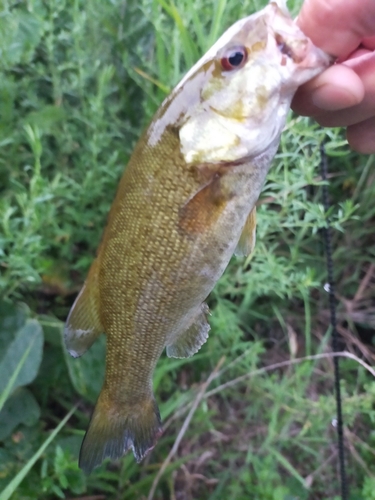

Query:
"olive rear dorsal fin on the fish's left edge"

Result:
[[64, 260, 104, 358]]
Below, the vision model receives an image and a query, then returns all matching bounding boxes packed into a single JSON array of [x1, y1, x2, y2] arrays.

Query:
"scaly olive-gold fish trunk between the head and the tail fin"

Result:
[[97, 122, 270, 390]]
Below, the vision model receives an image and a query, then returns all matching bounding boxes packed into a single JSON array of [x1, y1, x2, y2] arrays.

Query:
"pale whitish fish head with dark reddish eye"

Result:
[[149, 2, 331, 164]]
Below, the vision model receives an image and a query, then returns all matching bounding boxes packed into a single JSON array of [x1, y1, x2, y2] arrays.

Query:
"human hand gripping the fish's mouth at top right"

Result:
[[292, 0, 375, 154]]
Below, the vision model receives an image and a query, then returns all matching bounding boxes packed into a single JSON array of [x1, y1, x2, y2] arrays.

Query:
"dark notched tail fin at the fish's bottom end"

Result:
[[79, 391, 162, 474]]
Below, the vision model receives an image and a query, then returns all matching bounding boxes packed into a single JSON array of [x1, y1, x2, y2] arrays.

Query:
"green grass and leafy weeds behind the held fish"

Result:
[[0, 0, 375, 500]]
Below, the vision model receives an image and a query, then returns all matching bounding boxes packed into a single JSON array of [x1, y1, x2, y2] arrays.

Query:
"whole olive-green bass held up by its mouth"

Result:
[[65, 2, 331, 473]]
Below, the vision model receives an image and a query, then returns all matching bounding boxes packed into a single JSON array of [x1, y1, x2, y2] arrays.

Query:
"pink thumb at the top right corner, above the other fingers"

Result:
[[297, 0, 375, 57]]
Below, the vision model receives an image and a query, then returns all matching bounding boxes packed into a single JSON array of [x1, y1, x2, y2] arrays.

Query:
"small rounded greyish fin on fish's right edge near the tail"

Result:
[[167, 304, 210, 358]]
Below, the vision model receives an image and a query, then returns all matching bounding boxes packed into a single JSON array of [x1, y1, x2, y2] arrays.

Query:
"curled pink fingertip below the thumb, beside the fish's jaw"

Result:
[[292, 64, 364, 116]]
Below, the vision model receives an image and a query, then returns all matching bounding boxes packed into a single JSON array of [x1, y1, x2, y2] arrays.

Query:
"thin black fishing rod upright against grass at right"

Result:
[[320, 143, 348, 500]]
